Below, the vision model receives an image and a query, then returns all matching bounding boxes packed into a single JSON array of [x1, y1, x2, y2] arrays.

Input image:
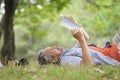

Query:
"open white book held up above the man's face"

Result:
[[60, 15, 80, 30]]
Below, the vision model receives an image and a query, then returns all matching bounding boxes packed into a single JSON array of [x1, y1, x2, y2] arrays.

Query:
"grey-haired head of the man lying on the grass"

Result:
[[38, 46, 63, 65]]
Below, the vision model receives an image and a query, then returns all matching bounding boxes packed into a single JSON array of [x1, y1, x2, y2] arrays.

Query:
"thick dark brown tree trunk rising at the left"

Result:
[[1, 0, 19, 65]]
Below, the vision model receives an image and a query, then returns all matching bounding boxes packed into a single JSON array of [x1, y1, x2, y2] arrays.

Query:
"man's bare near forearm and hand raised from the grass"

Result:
[[71, 29, 94, 65]]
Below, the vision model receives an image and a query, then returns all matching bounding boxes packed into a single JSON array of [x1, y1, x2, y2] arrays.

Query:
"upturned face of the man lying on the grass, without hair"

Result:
[[44, 46, 63, 63]]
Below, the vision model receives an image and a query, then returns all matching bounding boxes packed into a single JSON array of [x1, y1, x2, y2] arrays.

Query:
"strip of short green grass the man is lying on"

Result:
[[0, 61, 120, 80]]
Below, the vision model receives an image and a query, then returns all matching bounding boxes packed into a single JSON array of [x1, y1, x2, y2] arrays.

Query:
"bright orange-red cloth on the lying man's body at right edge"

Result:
[[89, 44, 120, 62]]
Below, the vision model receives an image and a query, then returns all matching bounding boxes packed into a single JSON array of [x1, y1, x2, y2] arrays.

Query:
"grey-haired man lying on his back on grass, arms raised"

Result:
[[38, 16, 120, 66]]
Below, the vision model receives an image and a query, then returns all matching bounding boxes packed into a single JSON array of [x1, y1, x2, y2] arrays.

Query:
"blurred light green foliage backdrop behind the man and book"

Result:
[[9, 0, 120, 57]]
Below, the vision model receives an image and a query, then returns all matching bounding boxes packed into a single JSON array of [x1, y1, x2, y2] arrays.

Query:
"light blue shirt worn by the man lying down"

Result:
[[60, 47, 120, 66]]
